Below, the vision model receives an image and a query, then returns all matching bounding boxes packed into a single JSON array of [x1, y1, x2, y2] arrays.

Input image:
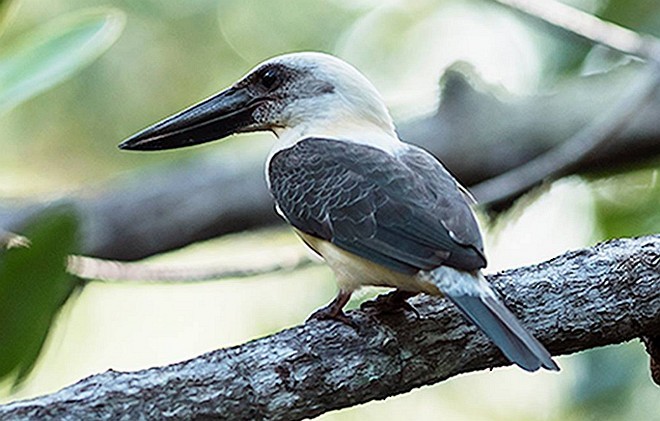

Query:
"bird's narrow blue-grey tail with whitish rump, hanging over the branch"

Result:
[[431, 267, 559, 371]]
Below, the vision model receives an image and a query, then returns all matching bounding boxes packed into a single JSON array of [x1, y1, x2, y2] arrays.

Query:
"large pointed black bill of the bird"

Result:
[[119, 87, 259, 151]]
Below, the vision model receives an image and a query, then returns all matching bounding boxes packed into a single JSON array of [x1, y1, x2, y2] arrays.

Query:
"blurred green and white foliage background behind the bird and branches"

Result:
[[0, 0, 660, 420]]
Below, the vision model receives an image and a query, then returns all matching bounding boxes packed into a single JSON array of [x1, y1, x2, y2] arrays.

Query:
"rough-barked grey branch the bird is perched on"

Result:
[[0, 235, 660, 420]]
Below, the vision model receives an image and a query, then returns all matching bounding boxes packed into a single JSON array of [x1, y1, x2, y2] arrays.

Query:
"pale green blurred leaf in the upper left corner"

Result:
[[0, 8, 125, 114]]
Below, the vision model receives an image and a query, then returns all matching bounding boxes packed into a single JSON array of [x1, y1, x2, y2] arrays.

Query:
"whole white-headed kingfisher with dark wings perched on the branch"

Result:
[[119, 52, 559, 371]]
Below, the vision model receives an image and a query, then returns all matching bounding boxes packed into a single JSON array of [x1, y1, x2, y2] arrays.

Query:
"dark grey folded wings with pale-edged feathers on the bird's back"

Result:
[[268, 138, 486, 274]]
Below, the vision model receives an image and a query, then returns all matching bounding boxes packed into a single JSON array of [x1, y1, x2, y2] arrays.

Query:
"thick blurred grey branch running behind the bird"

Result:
[[0, 65, 660, 260]]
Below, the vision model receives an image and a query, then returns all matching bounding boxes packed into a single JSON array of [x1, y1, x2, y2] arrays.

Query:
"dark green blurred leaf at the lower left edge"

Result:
[[0, 205, 78, 385]]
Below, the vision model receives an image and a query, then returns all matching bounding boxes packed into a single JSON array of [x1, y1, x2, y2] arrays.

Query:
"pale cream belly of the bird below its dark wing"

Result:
[[295, 230, 440, 295]]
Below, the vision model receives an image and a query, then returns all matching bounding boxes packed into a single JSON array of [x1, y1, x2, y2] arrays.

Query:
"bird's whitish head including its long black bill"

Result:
[[119, 52, 394, 150]]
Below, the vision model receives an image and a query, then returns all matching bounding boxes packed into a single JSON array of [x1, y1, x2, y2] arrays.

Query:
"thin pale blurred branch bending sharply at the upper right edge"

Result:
[[471, 0, 660, 206]]
